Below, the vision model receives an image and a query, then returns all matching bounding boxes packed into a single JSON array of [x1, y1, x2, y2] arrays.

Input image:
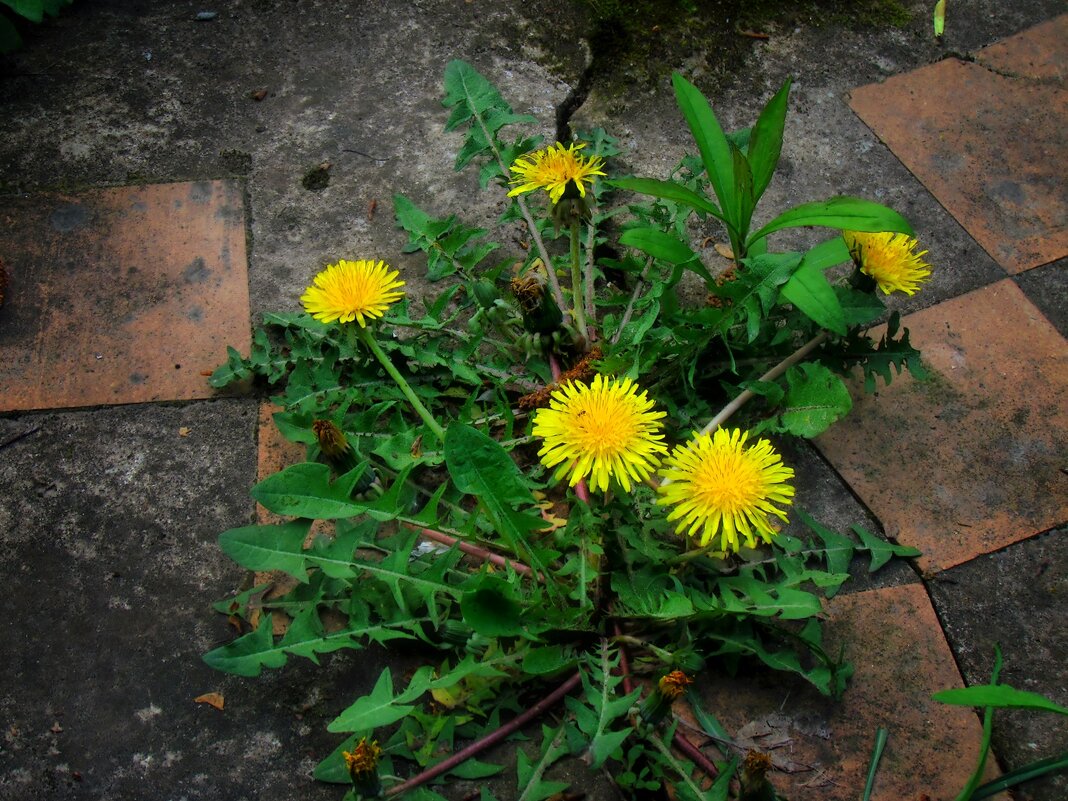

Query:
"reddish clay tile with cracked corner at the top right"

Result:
[[850, 15, 1068, 274]]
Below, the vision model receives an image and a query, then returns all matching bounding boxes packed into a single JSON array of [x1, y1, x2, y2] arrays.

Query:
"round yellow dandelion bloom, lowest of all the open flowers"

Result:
[[657, 428, 794, 552]]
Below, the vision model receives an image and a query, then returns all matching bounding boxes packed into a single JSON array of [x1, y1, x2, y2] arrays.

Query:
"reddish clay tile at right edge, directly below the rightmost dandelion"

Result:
[[817, 280, 1068, 570]]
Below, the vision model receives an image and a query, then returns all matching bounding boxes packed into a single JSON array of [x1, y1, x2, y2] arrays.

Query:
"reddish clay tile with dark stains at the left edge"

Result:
[[0, 180, 250, 411]]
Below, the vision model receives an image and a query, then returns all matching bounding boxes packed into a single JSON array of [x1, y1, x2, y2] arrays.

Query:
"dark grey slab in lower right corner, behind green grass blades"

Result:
[[929, 529, 1068, 801]]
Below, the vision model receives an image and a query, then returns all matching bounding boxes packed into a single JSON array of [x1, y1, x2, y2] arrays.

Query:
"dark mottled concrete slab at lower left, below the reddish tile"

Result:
[[0, 401, 381, 801]]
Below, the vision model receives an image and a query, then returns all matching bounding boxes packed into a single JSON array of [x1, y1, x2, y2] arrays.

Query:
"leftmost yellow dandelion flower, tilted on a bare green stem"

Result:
[[300, 258, 404, 328]]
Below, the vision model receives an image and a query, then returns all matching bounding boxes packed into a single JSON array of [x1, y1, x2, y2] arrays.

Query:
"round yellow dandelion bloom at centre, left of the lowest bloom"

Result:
[[534, 375, 668, 492]]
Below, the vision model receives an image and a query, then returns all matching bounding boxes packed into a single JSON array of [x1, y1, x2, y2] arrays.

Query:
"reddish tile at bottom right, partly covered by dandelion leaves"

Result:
[[689, 584, 1005, 801]]
